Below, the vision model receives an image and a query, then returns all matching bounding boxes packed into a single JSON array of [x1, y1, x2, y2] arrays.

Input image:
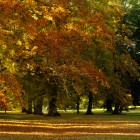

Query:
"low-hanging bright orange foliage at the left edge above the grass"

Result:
[[0, 72, 23, 109]]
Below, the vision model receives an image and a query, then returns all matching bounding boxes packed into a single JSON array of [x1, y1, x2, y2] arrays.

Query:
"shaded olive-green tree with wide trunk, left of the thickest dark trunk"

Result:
[[19, 72, 49, 115]]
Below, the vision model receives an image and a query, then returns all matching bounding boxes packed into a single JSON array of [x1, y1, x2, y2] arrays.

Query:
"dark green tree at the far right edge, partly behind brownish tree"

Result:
[[118, 0, 140, 105]]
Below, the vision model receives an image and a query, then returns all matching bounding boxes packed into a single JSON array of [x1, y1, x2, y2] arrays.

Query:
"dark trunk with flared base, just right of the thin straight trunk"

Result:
[[85, 91, 93, 115]]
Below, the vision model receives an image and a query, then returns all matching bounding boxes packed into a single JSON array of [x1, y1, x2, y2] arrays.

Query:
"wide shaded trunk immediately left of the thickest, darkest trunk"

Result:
[[34, 96, 43, 115]]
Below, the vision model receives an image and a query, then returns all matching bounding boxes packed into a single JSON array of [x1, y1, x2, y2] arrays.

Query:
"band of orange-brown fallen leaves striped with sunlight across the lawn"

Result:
[[0, 120, 140, 137]]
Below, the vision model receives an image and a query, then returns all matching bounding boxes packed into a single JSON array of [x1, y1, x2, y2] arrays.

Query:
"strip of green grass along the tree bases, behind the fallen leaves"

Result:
[[0, 110, 140, 122]]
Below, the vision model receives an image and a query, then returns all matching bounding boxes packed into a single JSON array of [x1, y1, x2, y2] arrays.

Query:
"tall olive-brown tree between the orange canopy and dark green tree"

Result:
[[97, 1, 138, 114]]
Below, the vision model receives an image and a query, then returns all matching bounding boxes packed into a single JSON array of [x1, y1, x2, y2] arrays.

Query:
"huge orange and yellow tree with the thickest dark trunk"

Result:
[[0, 0, 123, 115]]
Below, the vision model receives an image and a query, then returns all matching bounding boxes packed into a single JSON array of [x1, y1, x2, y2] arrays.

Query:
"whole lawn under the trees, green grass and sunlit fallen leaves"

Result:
[[0, 109, 140, 140]]
